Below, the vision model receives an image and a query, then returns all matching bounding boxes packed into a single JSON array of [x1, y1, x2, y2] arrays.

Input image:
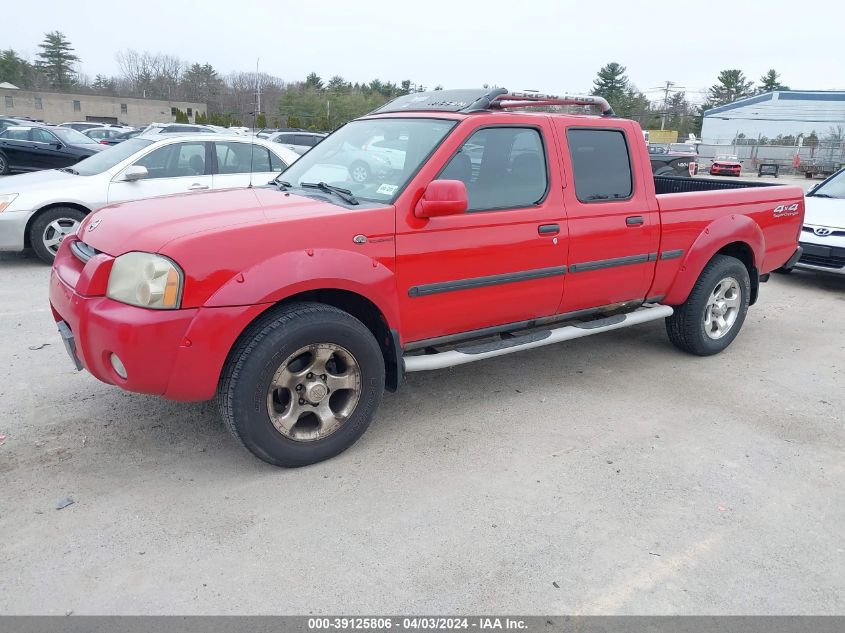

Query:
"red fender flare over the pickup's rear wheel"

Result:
[[662, 214, 766, 305]]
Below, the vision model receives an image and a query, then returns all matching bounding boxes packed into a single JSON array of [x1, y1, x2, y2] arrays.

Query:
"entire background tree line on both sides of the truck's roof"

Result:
[[0, 31, 804, 137]]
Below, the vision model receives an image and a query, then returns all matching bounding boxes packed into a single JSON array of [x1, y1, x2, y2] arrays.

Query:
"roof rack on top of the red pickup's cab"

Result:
[[370, 88, 613, 116]]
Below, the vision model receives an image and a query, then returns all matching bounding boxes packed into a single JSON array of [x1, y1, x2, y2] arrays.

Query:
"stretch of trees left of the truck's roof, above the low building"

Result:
[[0, 31, 422, 130]]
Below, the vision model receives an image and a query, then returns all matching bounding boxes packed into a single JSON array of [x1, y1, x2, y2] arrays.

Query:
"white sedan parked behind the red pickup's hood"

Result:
[[0, 134, 299, 263]]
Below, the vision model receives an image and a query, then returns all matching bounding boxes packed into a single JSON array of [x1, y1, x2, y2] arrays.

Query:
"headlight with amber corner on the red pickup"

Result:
[[106, 252, 184, 310]]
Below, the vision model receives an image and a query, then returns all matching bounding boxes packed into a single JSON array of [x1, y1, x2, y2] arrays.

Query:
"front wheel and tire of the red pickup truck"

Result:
[[217, 303, 385, 467]]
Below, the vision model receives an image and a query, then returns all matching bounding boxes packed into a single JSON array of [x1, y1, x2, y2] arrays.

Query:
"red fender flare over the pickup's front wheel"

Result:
[[204, 248, 399, 330]]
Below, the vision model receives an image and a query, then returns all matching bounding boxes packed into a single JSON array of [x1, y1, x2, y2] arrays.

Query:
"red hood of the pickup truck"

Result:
[[77, 189, 337, 256]]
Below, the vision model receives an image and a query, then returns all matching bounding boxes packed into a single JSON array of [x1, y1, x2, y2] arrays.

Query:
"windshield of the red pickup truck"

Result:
[[278, 118, 455, 202]]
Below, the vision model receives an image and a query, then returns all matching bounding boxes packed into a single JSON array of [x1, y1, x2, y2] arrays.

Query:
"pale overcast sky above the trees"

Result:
[[6, 0, 845, 101]]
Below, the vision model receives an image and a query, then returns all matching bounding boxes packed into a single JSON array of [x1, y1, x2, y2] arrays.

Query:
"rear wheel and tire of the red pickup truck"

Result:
[[666, 255, 751, 356]]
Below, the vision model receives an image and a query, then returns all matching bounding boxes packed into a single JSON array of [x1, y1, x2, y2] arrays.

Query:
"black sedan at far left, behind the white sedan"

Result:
[[0, 125, 105, 175]]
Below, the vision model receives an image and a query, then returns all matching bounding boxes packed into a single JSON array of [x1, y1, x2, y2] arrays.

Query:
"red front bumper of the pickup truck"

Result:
[[50, 258, 267, 400]]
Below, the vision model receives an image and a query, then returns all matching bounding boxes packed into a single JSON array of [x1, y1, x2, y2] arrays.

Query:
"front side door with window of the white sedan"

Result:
[[108, 141, 213, 204]]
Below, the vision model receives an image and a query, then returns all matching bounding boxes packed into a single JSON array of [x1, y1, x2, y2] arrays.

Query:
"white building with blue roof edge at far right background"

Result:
[[701, 90, 845, 144]]
